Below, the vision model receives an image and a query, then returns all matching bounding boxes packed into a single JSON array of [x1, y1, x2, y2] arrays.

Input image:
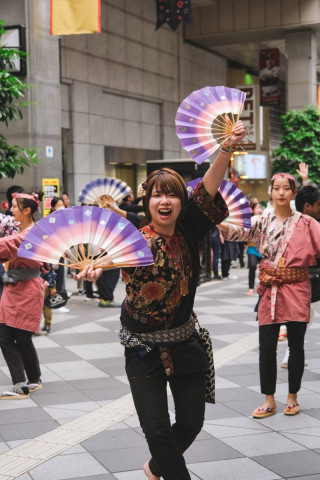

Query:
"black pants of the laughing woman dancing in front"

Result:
[[130, 372, 205, 480]]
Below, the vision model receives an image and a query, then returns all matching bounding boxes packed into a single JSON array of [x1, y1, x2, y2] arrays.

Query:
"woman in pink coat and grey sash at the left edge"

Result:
[[0, 193, 45, 400]]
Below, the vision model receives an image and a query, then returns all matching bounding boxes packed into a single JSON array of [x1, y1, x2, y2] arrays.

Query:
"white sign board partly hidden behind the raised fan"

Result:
[[237, 85, 259, 151]]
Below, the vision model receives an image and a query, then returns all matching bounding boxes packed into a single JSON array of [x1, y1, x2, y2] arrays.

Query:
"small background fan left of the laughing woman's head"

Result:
[[78, 177, 131, 206]]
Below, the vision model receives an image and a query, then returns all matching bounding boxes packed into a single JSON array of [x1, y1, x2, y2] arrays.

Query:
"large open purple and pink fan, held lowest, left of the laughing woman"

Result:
[[18, 206, 153, 270]]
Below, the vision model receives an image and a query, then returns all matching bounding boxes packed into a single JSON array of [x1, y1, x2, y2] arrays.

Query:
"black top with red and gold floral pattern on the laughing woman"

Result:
[[121, 182, 228, 378]]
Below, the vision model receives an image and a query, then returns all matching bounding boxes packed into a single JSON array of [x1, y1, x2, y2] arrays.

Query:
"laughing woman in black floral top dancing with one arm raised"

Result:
[[76, 122, 244, 480]]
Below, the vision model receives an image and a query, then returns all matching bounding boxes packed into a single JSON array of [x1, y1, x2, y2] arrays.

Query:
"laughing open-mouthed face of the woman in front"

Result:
[[149, 185, 181, 235]]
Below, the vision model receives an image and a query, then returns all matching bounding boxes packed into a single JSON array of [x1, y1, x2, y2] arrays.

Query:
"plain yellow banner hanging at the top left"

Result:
[[50, 0, 101, 35]]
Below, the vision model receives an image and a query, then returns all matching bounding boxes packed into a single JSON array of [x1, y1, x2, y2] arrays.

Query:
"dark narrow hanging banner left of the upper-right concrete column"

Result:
[[259, 48, 280, 106]]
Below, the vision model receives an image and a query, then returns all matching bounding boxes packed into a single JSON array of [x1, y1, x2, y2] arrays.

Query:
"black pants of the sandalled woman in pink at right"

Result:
[[259, 322, 308, 395]]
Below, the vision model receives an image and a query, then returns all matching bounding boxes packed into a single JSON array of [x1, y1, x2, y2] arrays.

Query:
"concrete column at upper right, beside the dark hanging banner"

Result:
[[286, 30, 317, 109]]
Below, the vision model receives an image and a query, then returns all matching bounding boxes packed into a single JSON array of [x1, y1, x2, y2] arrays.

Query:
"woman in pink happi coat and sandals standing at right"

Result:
[[219, 173, 320, 418]]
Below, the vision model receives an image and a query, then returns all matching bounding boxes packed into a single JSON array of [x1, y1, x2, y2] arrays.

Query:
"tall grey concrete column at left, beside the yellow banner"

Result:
[[25, 0, 62, 188]]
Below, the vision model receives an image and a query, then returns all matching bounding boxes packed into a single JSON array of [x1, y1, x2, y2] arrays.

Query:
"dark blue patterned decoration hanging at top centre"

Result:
[[156, 0, 193, 31]]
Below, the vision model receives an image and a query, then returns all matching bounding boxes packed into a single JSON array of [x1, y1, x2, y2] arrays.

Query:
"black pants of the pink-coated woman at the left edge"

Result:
[[0, 323, 41, 385]]
